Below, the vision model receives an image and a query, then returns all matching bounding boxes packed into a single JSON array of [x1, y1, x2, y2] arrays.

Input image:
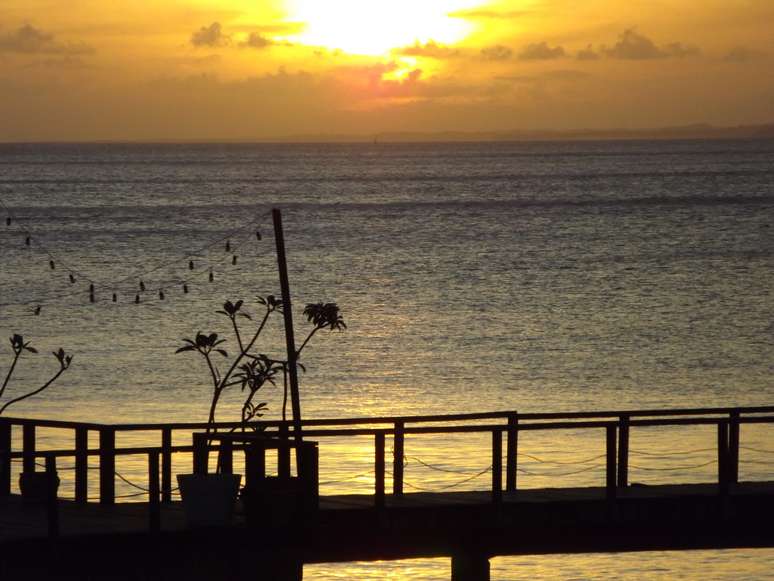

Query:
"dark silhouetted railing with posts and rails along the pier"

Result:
[[0, 406, 774, 507]]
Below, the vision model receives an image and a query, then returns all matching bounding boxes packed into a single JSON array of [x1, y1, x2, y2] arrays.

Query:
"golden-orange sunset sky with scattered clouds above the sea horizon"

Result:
[[0, 0, 774, 141]]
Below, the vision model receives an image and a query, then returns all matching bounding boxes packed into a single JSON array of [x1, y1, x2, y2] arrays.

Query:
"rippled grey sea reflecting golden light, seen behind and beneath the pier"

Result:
[[0, 141, 774, 580]]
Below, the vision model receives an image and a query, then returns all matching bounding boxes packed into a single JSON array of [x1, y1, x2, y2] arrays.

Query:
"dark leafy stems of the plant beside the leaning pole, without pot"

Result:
[[175, 295, 346, 432]]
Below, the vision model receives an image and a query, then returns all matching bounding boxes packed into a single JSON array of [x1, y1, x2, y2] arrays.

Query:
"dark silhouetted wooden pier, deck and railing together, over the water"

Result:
[[0, 407, 774, 581]]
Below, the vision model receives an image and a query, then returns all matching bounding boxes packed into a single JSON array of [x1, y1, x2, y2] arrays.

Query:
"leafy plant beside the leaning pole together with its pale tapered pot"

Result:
[[176, 295, 346, 526]]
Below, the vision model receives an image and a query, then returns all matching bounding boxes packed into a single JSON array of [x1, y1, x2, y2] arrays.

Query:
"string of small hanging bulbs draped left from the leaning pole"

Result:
[[0, 200, 271, 315]]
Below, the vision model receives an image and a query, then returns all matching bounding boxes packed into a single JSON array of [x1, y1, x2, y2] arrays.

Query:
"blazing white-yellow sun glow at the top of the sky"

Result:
[[288, 0, 481, 56]]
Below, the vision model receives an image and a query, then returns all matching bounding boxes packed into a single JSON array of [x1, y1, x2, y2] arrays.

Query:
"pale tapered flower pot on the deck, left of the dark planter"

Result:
[[177, 474, 242, 528]]
